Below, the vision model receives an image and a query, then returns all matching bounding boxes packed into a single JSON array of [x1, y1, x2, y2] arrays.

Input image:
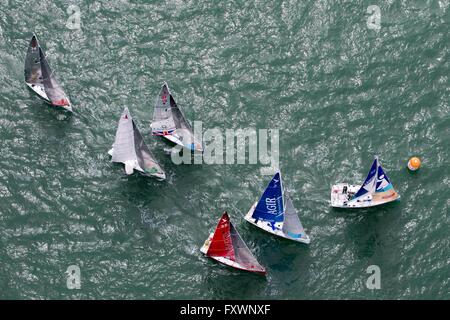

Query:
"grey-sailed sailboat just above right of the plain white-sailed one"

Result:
[[150, 82, 203, 152]]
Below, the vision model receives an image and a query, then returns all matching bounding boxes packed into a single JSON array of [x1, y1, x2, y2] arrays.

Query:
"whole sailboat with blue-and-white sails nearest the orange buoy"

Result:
[[331, 157, 400, 208]]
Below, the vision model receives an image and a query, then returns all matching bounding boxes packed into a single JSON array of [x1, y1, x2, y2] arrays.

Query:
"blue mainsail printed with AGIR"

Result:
[[252, 172, 284, 223]]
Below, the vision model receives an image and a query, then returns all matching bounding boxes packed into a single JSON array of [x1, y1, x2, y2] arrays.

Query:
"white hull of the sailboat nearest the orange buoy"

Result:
[[331, 183, 400, 208]]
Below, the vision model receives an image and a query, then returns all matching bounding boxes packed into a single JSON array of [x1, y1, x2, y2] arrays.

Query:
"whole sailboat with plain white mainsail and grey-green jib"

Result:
[[108, 107, 166, 180]]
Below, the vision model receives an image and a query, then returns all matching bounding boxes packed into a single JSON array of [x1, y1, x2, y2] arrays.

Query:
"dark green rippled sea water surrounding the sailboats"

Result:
[[0, 0, 450, 299]]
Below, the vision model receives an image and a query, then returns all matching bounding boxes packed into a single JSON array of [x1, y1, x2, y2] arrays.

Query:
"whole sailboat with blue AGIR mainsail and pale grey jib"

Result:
[[244, 171, 311, 244]]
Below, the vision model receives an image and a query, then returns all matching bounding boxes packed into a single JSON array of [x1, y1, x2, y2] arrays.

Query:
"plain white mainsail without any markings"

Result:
[[112, 107, 137, 163]]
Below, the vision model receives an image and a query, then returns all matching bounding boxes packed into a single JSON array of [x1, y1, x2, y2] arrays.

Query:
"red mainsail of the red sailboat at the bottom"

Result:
[[206, 212, 236, 261]]
